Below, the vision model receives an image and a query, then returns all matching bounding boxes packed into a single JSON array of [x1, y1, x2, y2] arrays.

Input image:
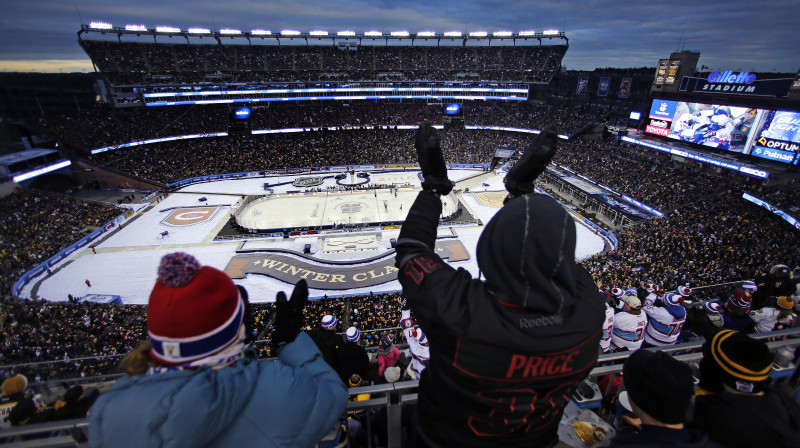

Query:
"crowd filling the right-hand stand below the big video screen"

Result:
[[556, 141, 800, 288]]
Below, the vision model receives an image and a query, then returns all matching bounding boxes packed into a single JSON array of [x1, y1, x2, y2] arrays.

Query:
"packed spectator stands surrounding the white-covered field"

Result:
[[0, 23, 800, 446]]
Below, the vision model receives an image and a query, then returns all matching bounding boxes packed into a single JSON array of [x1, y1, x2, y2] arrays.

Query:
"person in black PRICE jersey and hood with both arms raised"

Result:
[[396, 123, 605, 447]]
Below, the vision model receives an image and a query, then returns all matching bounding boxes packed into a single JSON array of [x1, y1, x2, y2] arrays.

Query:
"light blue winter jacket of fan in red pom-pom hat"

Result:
[[89, 333, 348, 448]]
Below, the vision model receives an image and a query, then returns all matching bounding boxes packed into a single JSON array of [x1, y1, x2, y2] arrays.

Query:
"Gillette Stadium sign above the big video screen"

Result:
[[679, 70, 793, 97]]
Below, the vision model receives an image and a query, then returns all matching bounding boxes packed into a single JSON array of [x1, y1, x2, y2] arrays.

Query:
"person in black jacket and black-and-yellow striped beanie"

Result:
[[689, 330, 800, 448]]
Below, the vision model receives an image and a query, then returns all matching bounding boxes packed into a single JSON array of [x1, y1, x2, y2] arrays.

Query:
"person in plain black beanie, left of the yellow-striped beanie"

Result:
[[610, 350, 720, 447]]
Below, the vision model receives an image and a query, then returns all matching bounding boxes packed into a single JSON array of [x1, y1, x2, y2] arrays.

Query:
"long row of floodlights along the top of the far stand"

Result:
[[78, 22, 569, 45]]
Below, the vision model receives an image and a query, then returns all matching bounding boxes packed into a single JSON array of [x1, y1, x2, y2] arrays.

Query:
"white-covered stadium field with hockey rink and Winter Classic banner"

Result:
[[21, 170, 605, 304]]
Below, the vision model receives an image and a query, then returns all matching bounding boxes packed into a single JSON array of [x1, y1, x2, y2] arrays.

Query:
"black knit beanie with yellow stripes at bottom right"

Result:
[[700, 330, 775, 393]]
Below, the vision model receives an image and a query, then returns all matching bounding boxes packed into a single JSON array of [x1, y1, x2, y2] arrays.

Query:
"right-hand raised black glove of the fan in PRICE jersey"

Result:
[[505, 128, 558, 196]]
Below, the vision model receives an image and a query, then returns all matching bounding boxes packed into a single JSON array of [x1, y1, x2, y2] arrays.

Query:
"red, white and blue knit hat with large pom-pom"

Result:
[[147, 252, 244, 366]]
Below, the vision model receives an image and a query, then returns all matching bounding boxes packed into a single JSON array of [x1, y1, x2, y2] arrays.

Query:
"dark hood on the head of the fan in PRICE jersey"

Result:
[[478, 194, 578, 313]]
